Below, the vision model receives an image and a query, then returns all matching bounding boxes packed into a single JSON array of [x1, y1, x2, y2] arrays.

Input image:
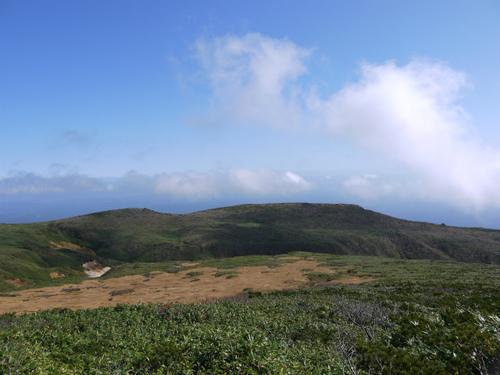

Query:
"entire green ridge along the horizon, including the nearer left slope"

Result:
[[0, 203, 500, 289]]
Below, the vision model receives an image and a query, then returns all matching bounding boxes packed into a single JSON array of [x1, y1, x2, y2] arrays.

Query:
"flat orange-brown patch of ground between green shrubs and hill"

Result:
[[0, 260, 373, 314]]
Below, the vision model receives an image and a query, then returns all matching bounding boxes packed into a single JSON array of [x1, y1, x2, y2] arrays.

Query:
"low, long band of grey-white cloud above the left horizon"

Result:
[[0, 167, 314, 200]]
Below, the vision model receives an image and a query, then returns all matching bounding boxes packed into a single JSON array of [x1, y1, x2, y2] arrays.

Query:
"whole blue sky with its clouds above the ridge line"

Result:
[[0, 0, 500, 229]]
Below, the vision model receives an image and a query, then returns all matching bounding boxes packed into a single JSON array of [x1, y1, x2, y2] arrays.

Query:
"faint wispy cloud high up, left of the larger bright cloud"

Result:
[[196, 33, 310, 128]]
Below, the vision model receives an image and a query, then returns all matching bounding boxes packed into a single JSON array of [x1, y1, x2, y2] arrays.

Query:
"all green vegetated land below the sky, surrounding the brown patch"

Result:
[[0, 203, 500, 375]]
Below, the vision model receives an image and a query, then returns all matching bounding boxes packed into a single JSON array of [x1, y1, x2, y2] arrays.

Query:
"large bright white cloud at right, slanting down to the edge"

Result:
[[322, 59, 500, 212]]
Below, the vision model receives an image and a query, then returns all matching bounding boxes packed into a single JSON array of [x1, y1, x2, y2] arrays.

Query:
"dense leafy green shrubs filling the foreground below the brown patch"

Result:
[[0, 283, 500, 374]]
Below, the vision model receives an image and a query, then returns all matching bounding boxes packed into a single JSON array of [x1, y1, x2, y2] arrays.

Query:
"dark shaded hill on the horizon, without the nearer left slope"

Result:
[[50, 203, 500, 263]]
